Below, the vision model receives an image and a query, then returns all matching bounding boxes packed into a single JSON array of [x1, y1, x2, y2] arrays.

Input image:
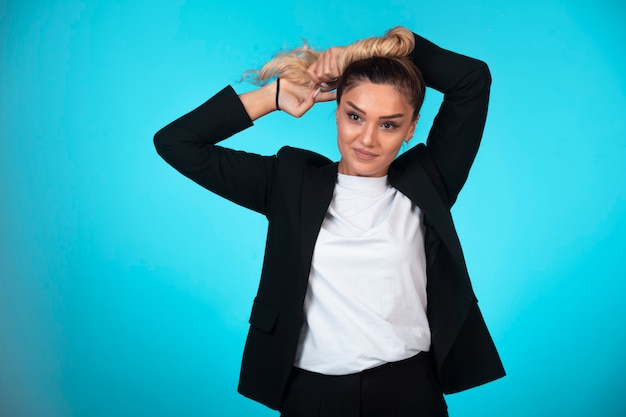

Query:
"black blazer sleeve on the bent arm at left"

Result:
[[154, 86, 276, 215]]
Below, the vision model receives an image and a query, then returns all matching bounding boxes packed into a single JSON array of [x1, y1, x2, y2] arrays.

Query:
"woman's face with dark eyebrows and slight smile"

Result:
[[335, 82, 417, 177]]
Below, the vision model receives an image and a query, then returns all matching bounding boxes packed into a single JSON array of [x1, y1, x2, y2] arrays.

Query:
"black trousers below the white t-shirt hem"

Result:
[[280, 352, 448, 417]]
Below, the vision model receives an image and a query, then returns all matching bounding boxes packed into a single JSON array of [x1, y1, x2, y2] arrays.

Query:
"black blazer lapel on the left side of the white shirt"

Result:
[[301, 163, 338, 284]]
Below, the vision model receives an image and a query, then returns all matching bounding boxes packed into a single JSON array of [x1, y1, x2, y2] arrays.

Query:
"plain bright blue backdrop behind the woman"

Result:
[[0, 0, 626, 417]]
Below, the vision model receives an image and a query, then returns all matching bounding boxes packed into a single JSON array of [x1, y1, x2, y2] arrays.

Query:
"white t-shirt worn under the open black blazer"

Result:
[[294, 174, 430, 375]]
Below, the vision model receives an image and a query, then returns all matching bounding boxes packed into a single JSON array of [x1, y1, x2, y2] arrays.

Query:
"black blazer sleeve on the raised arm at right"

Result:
[[411, 34, 491, 207]]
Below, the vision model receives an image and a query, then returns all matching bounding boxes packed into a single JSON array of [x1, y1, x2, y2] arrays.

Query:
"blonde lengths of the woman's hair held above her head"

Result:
[[244, 26, 415, 88]]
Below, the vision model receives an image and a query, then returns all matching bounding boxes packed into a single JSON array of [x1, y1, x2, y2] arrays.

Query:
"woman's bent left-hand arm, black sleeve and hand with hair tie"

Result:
[[154, 80, 335, 214]]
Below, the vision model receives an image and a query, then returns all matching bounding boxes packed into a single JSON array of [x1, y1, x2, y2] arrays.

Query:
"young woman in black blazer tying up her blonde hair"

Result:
[[155, 28, 504, 417]]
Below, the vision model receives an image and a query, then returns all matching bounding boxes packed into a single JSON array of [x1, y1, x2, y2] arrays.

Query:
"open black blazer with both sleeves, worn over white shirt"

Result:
[[155, 35, 504, 409]]
